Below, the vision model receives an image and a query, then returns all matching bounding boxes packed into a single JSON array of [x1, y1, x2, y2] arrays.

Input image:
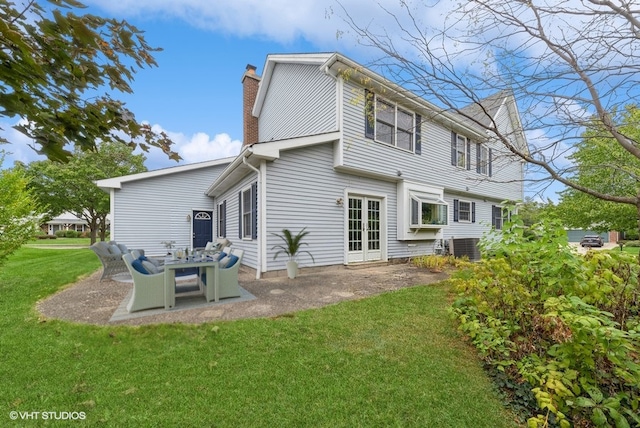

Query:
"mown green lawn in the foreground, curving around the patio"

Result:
[[0, 248, 514, 428]]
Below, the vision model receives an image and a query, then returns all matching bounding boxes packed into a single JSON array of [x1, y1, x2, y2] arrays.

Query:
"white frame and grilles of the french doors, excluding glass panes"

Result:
[[344, 189, 388, 264]]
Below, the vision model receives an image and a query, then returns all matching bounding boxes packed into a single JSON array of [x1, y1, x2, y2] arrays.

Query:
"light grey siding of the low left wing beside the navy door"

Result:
[[111, 165, 225, 255]]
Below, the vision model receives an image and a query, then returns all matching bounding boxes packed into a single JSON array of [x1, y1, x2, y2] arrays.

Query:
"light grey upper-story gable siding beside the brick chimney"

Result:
[[258, 64, 337, 141]]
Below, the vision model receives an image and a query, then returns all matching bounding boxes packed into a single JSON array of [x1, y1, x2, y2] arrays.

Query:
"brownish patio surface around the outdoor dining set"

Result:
[[37, 263, 447, 325]]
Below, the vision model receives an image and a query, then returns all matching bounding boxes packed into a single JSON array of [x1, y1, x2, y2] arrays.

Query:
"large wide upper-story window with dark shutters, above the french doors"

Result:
[[365, 90, 421, 154]]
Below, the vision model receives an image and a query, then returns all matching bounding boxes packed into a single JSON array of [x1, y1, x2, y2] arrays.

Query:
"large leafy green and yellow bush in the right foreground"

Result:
[[452, 219, 640, 427]]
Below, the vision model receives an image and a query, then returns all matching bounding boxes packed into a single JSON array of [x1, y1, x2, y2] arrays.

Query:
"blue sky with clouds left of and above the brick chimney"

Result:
[[0, 0, 376, 170]]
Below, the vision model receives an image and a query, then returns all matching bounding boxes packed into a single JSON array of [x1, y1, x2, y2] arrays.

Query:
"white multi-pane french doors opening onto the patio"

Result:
[[347, 196, 384, 263]]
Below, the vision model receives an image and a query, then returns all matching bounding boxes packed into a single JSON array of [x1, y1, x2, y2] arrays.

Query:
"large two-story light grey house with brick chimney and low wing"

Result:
[[98, 53, 527, 277]]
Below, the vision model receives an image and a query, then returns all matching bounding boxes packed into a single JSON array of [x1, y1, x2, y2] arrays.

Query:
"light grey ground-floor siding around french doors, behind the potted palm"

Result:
[[266, 144, 399, 270]]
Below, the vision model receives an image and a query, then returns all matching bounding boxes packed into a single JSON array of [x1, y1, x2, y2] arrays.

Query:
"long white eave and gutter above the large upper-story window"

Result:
[[322, 54, 487, 140]]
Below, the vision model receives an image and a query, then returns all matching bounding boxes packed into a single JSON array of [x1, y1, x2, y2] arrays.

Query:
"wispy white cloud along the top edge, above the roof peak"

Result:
[[81, 0, 442, 46]]
